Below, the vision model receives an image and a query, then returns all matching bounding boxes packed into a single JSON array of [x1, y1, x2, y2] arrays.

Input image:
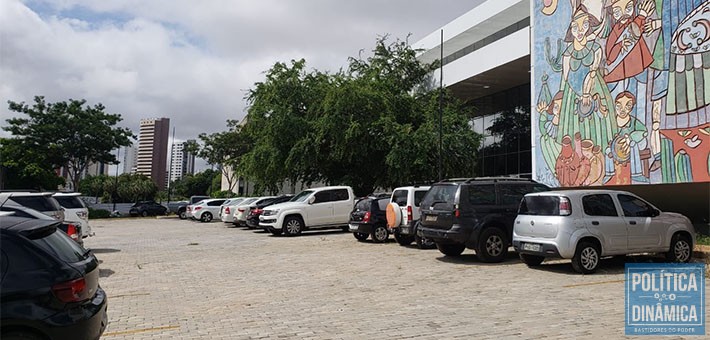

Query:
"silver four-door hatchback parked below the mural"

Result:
[[513, 190, 695, 274]]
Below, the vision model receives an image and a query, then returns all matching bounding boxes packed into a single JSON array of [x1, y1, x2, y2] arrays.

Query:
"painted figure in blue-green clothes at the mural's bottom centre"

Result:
[[605, 91, 648, 185]]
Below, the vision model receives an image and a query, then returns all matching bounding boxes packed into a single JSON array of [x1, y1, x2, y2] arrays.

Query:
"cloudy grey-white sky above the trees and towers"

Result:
[[0, 0, 482, 170]]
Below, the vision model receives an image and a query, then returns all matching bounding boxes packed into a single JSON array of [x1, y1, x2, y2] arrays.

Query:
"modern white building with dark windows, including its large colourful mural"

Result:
[[413, 0, 710, 232]]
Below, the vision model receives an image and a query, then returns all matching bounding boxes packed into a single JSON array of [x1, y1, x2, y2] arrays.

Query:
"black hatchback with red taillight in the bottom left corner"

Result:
[[0, 216, 108, 340]]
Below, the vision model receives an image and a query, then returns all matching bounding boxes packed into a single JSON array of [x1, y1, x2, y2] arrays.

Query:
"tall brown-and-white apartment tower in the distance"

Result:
[[136, 118, 170, 190]]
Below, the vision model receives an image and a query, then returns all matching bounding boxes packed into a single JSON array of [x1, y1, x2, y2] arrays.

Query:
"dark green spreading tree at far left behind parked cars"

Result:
[[3, 96, 134, 191]]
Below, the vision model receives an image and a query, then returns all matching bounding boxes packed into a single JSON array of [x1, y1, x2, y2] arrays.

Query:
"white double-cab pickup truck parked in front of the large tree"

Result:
[[259, 186, 355, 236]]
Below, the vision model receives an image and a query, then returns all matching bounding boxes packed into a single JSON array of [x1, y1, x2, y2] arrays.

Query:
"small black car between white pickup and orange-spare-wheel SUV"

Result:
[[348, 197, 390, 243]]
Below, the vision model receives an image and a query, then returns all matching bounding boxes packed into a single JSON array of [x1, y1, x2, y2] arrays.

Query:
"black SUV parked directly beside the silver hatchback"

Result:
[[420, 177, 550, 262]]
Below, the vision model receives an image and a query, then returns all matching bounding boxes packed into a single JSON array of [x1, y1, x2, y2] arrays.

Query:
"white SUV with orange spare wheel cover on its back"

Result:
[[387, 186, 435, 249]]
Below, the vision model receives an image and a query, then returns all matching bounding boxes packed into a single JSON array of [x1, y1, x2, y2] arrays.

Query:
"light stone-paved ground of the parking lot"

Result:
[[85, 218, 708, 339]]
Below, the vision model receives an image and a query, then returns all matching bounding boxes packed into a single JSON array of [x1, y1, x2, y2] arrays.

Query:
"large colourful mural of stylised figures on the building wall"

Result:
[[532, 0, 710, 187]]
